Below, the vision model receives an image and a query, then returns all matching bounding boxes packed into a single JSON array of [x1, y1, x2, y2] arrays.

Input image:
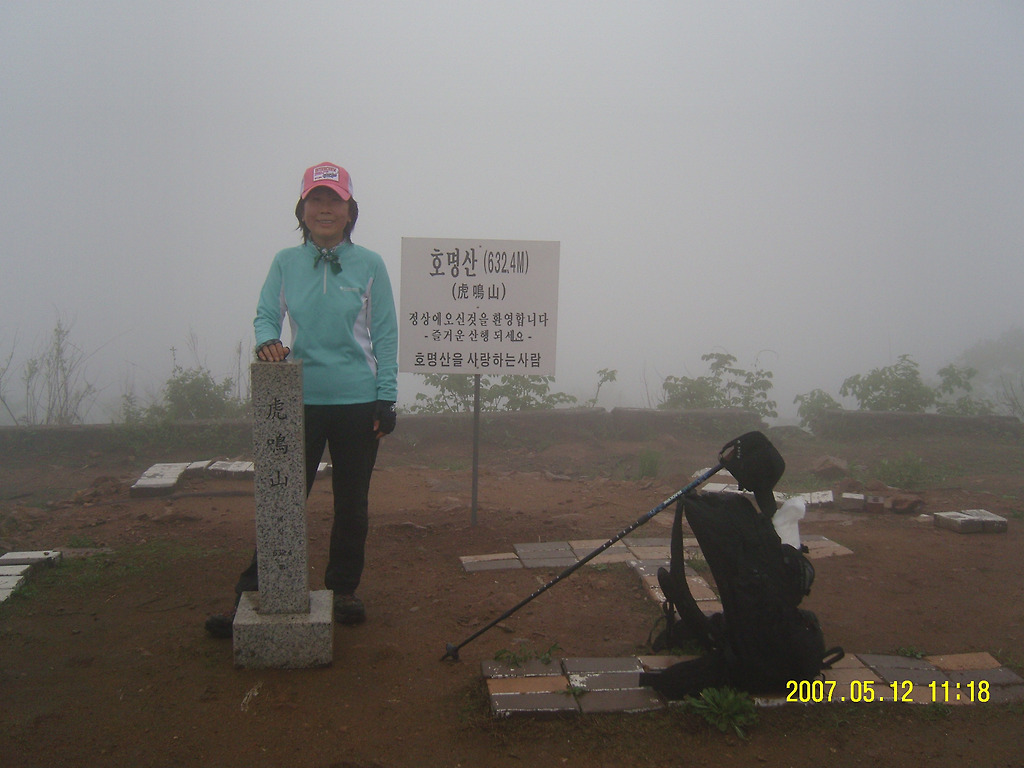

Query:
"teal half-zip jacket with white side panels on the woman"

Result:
[[253, 243, 398, 406]]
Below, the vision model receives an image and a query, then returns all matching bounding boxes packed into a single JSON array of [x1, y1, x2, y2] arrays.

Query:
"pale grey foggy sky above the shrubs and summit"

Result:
[[0, 0, 1024, 421]]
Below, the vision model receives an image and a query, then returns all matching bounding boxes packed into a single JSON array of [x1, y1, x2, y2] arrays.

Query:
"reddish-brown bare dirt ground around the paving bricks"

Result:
[[0, 419, 1024, 768]]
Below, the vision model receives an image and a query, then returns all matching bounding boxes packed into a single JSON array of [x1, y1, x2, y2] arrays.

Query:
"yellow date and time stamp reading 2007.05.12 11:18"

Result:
[[785, 680, 991, 703]]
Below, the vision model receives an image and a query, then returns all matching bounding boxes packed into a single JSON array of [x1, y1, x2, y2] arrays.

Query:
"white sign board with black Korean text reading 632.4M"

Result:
[[398, 238, 559, 376]]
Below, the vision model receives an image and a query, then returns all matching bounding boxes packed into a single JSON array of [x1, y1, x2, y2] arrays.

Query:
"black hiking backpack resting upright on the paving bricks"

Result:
[[640, 494, 843, 699]]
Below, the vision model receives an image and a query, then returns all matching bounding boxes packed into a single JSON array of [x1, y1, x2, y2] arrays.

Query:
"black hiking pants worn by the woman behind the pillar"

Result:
[[234, 402, 378, 596]]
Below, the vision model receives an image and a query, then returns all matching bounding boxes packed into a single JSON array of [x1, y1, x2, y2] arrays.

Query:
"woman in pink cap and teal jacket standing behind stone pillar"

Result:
[[206, 163, 398, 637]]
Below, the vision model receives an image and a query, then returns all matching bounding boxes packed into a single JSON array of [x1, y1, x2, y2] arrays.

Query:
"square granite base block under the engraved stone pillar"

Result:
[[232, 590, 334, 669]]
